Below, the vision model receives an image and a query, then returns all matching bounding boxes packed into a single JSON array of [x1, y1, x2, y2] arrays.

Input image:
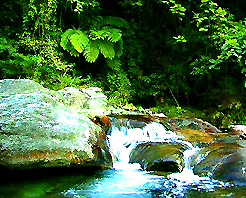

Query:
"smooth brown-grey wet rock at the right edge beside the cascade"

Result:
[[194, 140, 246, 185]]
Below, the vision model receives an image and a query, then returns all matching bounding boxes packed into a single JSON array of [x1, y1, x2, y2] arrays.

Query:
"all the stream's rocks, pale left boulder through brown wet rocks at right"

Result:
[[0, 79, 246, 185]]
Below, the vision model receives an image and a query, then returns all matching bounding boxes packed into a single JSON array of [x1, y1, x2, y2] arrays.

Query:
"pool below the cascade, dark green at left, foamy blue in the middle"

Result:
[[0, 165, 246, 198]]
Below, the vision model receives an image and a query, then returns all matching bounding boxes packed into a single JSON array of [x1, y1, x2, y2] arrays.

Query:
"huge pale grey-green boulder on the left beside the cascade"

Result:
[[0, 79, 112, 169]]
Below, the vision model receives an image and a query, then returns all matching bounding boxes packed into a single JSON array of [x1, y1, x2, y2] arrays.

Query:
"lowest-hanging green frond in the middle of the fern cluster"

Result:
[[83, 40, 99, 63]]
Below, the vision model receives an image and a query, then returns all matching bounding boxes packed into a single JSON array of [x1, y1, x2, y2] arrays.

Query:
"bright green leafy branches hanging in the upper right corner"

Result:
[[192, 0, 246, 74]]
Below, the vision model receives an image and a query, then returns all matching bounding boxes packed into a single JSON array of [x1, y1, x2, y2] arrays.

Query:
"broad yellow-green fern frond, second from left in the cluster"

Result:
[[70, 31, 89, 53]]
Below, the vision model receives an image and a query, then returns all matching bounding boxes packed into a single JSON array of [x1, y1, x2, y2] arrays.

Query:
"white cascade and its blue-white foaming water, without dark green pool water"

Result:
[[62, 122, 233, 198]]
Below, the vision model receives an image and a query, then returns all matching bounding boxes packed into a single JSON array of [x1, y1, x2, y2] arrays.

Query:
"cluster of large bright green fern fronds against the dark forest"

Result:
[[61, 16, 127, 62]]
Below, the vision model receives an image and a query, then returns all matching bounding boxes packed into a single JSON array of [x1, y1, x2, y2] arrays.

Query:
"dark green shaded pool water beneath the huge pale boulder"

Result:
[[0, 168, 95, 198]]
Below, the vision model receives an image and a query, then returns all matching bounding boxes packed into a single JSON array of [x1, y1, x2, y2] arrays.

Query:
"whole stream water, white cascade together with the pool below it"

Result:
[[0, 120, 245, 198]]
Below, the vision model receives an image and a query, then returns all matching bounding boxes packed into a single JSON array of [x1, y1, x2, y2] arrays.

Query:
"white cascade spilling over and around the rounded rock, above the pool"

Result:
[[108, 122, 199, 169]]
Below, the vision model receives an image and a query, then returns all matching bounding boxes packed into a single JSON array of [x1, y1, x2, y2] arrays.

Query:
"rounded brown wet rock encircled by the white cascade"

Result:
[[129, 142, 185, 172]]
